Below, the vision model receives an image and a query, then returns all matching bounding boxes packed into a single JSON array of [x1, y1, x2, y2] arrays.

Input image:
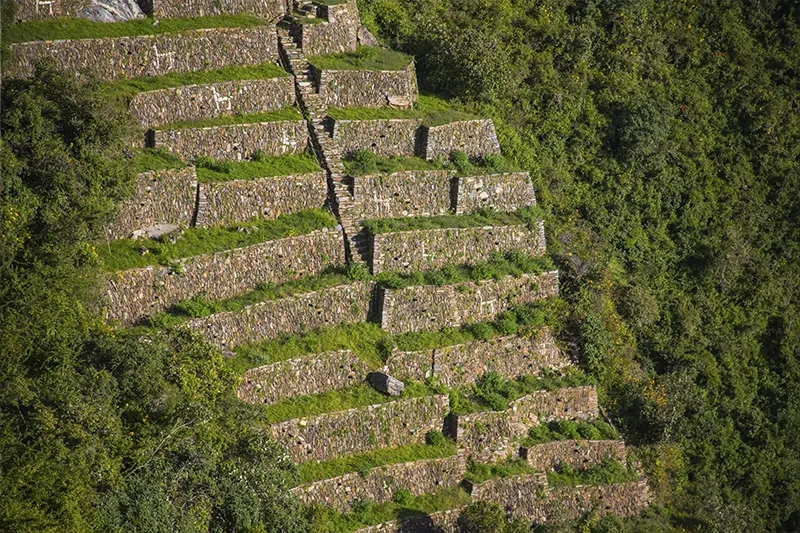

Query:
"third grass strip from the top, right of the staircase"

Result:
[[342, 150, 519, 176]]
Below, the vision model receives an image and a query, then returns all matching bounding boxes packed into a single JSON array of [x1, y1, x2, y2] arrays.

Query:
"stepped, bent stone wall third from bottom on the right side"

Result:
[[448, 387, 598, 461]]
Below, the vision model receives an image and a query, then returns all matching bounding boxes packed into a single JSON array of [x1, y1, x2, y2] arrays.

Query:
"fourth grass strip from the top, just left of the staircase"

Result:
[[194, 152, 321, 183]]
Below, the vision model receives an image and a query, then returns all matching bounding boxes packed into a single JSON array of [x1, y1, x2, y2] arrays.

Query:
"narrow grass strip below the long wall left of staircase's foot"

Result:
[[148, 269, 350, 328]]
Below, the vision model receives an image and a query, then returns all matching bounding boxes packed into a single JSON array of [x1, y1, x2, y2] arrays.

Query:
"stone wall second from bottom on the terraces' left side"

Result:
[[290, 456, 467, 513]]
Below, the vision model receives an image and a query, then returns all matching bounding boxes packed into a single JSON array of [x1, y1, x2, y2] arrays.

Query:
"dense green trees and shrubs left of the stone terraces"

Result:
[[0, 68, 307, 533]]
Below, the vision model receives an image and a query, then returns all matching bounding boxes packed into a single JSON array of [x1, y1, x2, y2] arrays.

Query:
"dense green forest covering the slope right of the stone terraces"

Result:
[[359, 0, 800, 532]]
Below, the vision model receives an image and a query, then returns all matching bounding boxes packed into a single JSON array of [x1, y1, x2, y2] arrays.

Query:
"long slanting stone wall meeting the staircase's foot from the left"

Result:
[[106, 230, 344, 324]]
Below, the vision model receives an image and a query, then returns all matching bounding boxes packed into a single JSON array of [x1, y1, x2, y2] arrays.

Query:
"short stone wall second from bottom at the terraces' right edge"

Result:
[[519, 440, 627, 472]]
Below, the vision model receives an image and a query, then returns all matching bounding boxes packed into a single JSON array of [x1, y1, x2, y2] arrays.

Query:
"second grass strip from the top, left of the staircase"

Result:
[[102, 63, 289, 101]]
